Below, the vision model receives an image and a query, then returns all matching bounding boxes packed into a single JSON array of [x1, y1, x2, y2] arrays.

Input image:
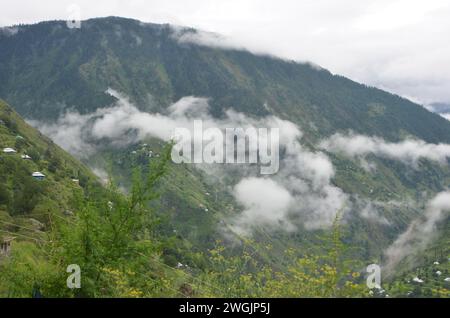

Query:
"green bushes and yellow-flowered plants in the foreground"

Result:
[[0, 146, 448, 297]]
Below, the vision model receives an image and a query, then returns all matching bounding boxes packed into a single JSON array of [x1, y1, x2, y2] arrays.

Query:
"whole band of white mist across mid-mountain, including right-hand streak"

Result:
[[31, 90, 450, 270]]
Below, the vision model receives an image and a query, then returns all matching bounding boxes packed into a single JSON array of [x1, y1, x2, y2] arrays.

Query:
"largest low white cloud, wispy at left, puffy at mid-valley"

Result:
[[32, 89, 348, 235]]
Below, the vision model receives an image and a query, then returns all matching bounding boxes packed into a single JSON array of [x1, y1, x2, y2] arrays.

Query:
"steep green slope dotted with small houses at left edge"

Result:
[[0, 100, 101, 239]]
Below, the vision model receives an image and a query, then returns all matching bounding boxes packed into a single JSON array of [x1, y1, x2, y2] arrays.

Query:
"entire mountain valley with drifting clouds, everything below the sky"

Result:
[[0, 17, 450, 297]]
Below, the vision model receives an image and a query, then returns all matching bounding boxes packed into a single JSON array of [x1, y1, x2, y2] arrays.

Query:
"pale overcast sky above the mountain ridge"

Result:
[[0, 0, 450, 103]]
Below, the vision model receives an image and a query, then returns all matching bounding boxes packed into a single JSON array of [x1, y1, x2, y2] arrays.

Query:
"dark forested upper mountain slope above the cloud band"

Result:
[[0, 18, 450, 142]]
